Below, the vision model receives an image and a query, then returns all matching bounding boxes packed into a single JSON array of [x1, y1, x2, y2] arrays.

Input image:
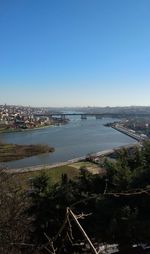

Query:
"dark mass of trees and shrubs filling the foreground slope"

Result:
[[0, 142, 150, 254]]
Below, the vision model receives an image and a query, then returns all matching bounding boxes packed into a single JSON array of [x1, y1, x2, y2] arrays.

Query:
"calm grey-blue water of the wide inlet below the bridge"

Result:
[[0, 116, 136, 168]]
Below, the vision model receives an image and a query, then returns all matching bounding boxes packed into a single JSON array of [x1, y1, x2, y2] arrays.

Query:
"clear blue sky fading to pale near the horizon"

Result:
[[0, 0, 150, 106]]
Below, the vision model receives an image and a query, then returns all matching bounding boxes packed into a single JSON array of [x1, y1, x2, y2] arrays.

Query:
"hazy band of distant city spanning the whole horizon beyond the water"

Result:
[[0, 104, 150, 137]]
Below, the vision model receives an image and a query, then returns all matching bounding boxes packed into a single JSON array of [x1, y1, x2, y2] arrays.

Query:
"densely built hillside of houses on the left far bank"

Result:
[[0, 104, 67, 132]]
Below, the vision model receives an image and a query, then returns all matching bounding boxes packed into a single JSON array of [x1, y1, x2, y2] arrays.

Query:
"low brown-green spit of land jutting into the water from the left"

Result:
[[0, 143, 54, 162]]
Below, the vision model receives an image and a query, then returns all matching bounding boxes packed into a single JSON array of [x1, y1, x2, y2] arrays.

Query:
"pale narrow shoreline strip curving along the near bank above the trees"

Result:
[[4, 142, 140, 174]]
